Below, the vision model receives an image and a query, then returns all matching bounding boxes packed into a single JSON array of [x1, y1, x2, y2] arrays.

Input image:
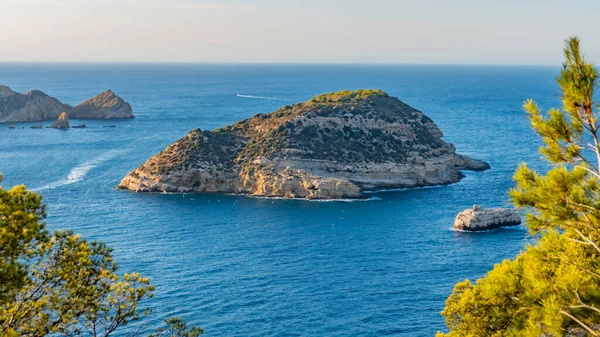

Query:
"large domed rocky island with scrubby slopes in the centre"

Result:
[[118, 90, 489, 199]]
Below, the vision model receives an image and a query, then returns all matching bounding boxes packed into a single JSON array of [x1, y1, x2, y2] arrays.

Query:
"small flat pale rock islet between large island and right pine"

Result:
[[454, 205, 521, 232]]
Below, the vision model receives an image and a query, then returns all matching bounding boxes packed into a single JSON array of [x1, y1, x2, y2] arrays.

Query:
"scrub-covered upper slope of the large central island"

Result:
[[135, 89, 446, 178]]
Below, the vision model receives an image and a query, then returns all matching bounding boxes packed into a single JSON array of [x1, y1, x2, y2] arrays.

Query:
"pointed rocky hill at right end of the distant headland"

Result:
[[69, 90, 135, 119]]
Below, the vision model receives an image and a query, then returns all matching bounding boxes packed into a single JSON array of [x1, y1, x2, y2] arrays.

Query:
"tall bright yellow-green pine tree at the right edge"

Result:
[[438, 38, 600, 337]]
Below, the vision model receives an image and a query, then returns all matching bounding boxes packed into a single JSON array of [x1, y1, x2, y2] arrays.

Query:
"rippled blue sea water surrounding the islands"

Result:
[[0, 63, 560, 336]]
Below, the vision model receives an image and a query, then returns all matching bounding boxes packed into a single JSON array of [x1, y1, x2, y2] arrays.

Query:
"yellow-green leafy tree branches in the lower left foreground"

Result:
[[0, 176, 203, 337]]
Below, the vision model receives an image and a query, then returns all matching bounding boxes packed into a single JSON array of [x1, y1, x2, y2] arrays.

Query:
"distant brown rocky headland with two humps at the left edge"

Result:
[[0, 85, 135, 123]]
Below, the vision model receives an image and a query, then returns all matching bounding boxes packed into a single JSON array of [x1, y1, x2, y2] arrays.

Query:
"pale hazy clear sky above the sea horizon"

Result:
[[0, 0, 600, 64]]
